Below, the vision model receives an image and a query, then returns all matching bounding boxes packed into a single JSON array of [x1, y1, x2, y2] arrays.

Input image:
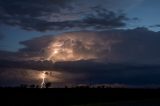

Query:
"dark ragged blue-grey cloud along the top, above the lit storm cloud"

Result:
[[0, 0, 132, 31]]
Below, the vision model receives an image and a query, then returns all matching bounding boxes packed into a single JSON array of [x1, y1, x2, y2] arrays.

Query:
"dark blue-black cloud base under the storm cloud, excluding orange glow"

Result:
[[0, 61, 160, 85]]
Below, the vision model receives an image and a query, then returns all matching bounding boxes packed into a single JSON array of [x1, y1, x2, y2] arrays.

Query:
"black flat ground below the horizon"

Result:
[[0, 88, 160, 106]]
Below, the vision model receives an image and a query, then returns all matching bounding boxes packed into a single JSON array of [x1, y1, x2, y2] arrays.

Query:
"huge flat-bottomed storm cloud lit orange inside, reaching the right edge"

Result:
[[10, 28, 160, 64]]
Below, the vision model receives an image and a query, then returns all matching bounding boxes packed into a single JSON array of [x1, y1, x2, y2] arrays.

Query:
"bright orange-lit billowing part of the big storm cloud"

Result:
[[46, 32, 120, 61]]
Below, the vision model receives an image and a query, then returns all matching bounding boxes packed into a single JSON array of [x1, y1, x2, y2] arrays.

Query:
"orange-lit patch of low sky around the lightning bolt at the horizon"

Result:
[[0, 68, 63, 87]]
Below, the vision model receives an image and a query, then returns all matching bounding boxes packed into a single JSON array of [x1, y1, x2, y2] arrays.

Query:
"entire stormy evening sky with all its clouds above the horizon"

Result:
[[0, 0, 160, 87]]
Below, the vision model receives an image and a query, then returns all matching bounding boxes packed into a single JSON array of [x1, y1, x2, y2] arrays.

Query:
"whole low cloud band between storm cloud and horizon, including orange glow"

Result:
[[0, 61, 160, 86]]
